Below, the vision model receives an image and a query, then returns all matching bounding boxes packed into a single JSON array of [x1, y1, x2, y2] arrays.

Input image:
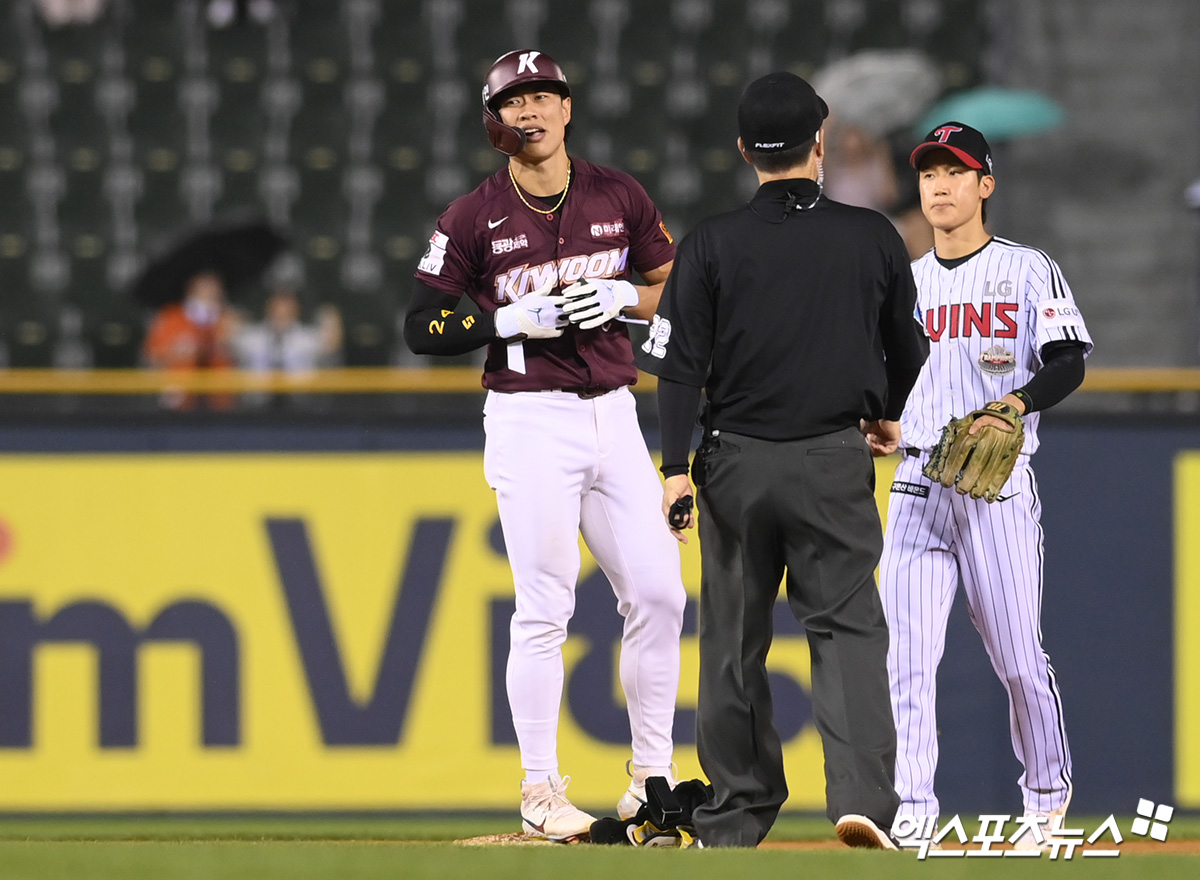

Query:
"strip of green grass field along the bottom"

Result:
[[0, 815, 1200, 880]]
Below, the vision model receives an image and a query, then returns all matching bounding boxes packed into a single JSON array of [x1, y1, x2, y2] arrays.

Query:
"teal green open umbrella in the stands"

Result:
[[914, 85, 1066, 140]]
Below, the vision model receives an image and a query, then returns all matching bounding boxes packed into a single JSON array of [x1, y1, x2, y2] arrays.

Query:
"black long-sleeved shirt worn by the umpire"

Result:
[[642, 178, 929, 475]]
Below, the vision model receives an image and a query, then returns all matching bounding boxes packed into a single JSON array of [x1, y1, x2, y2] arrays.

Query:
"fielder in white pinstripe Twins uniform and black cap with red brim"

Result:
[[881, 122, 1092, 846]]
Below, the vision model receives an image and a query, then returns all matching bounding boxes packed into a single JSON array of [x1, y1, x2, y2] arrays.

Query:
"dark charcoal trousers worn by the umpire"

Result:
[[695, 427, 900, 846]]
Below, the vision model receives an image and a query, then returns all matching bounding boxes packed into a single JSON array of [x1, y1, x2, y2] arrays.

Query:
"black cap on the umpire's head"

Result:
[[738, 71, 829, 152]]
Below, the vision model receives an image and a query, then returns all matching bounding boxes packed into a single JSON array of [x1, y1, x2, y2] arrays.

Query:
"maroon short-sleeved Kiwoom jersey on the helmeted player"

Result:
[[416, 158, 674, 391]]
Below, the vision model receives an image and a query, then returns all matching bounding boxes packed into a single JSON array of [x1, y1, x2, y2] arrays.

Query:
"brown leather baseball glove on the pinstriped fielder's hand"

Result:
[[922, 400, 1025, 502]]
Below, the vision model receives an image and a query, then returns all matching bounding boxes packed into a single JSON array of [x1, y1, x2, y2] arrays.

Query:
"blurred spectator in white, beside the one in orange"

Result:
[[234, 288, 342, 372]]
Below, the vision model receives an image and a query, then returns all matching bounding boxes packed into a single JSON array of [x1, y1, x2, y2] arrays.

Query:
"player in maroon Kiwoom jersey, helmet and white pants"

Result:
[[404, 49, 685, 840]]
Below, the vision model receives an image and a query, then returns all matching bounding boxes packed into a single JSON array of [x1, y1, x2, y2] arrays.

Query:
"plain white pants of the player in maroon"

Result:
[[484, 388, 686, 778]]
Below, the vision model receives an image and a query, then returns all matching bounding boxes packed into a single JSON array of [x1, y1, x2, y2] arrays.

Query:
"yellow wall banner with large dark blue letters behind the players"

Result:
[[0, 453, 902, 812]]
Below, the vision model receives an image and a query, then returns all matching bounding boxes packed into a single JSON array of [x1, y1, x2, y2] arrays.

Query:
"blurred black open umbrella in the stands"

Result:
[[133, 220, 288, 307]]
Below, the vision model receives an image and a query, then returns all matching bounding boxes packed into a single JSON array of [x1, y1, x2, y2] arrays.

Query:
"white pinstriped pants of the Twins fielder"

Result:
[[880, 455, 1070, 816]]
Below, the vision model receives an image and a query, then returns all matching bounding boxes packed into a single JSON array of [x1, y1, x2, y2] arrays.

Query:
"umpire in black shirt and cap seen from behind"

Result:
[[643, 73, 929, 849]]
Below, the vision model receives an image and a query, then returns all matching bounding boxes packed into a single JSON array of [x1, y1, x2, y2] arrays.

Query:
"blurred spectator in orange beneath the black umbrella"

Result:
[[143, 271, 238, 409]]
